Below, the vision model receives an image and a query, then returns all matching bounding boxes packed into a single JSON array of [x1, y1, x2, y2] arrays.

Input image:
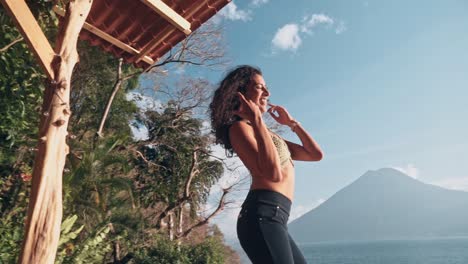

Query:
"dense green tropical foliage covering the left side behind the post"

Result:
[[0, 0, 236, 263]]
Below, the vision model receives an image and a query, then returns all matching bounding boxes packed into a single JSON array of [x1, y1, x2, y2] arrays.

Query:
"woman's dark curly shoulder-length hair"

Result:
[[209, 65, 262, 156]]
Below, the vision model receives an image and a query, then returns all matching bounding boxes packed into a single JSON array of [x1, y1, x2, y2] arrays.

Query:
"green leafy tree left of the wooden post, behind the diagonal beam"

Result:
[[0, 1, 56, 208]]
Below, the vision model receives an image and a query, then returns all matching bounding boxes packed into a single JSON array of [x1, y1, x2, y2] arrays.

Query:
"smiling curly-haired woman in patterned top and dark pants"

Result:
[[210, 65, 322, 264]]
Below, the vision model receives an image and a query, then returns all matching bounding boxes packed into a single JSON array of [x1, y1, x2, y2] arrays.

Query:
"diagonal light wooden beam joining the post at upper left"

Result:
[[0, 0, 55, 80]]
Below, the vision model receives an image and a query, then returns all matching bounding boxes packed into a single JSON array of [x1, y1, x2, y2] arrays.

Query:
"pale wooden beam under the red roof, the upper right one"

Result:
[[141, 0, 192, 35]]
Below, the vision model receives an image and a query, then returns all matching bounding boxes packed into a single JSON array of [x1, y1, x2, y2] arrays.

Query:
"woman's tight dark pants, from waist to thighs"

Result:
[[237, 190, 307, 264]]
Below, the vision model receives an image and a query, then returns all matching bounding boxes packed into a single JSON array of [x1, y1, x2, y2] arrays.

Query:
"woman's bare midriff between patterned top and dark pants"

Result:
[[250, 160, 294, 201]]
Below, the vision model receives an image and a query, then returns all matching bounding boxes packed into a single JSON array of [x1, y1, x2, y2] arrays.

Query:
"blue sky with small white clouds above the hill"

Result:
[[132, 0, 468, 243]]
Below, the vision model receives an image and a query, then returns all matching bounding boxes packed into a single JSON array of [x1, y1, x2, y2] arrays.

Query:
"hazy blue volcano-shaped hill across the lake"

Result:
[[288, 168, 468, 243]]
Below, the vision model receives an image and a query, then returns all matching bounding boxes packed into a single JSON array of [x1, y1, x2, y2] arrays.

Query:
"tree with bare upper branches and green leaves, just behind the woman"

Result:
[[130, 79, 239, 239]]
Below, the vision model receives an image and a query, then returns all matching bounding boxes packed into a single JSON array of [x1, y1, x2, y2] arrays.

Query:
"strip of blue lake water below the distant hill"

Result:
[[300, 238, 468, 264]]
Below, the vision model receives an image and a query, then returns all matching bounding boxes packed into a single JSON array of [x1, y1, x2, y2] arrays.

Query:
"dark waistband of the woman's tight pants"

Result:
[[242, 189, 292, 214]]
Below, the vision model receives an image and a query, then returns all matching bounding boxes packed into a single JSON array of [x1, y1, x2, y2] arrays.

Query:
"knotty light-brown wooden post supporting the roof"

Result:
[[18, 0, 92, 264]]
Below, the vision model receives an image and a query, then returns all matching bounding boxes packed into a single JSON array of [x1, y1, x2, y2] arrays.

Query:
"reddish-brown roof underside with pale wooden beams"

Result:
[[54, 0, 230, 68]]
